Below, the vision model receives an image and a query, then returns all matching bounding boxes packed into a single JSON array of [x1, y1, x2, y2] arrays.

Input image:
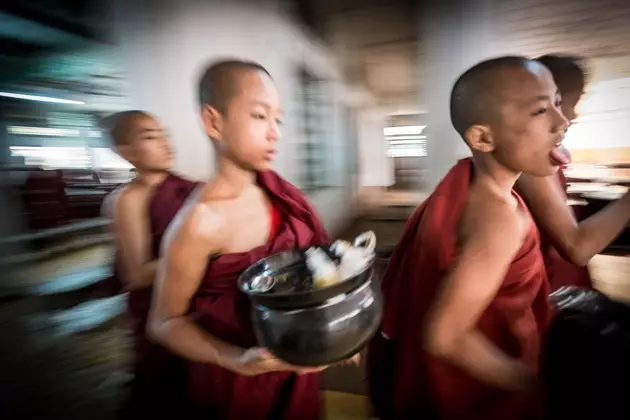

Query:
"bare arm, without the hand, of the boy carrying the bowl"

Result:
[[149, 207, 242, 366]]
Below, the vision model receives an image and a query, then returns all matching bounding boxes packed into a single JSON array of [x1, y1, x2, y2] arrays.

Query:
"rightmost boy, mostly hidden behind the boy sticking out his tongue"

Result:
[[516, 55, 630, 290]]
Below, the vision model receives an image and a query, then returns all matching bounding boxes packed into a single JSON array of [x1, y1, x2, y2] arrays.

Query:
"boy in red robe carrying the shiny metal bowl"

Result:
[[150, 60, 328, 420]]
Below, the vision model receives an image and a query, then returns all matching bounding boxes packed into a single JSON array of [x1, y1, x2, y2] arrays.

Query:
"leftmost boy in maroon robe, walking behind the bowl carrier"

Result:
[[103, 111, 196, 417]]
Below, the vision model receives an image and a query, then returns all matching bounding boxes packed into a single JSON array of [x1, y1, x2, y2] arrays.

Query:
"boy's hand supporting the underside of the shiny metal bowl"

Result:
[[225, 347, 325, 376]]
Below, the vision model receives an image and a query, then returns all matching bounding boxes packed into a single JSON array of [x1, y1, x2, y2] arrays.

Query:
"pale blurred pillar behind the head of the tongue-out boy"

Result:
[[420, 0, 493, 190]]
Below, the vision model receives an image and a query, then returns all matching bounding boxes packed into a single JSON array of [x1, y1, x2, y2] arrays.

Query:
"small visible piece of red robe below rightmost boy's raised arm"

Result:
[[542, 170, 593, 291]]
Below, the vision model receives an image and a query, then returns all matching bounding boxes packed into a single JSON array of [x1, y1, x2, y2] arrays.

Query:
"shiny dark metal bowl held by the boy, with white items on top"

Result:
[[238, 235, 383, 366]]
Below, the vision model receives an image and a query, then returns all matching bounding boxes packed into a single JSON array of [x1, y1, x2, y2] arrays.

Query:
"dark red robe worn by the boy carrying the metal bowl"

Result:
[[188, 172, 328, 420]]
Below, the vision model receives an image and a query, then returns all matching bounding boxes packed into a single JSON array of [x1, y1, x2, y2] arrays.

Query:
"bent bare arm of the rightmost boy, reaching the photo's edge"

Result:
[[516, 175, 630, 265]]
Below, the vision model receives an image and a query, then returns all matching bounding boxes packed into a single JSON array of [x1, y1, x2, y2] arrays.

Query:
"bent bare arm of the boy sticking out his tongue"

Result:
[[425, 205, 533, 390]]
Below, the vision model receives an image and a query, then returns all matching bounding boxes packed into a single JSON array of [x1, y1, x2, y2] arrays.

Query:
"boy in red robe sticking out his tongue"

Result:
[[368, 57, 569, 420]]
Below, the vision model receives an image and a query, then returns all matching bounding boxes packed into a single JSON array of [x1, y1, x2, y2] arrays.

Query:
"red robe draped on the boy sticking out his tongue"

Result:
[[368, 159, 549, 420]]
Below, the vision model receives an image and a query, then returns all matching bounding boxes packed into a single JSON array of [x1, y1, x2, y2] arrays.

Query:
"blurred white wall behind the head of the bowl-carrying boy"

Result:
[[115, 0, 354, 236]]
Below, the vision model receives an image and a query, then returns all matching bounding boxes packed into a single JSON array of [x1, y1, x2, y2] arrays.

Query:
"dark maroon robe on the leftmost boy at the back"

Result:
[[115, 174, 198, 416]]
